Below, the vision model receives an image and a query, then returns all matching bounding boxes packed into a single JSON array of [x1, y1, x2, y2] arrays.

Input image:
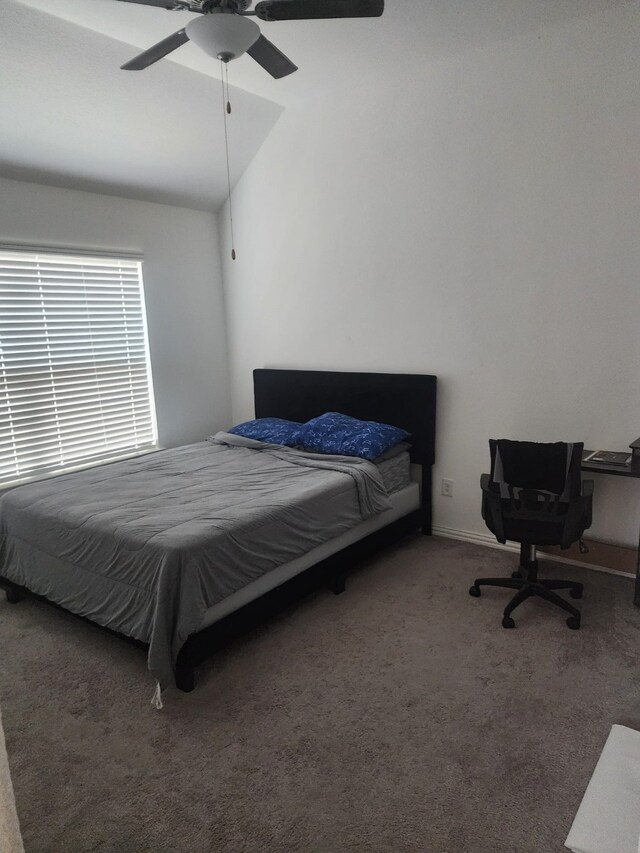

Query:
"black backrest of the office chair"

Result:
[[489, 438, 583, 502]]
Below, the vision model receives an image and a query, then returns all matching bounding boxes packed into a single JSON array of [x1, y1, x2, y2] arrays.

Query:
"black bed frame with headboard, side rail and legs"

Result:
[[0, 370, 436, 692]]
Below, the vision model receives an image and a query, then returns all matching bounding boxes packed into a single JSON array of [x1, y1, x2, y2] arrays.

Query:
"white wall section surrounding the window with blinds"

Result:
[[0, 179, 230, 447]]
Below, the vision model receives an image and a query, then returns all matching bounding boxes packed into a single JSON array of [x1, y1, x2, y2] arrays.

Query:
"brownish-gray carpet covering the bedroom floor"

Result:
[[0, 536, 640, 853]]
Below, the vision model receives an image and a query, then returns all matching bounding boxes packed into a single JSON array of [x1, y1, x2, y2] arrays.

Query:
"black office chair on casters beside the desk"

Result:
[[469, 439, 593, 629]]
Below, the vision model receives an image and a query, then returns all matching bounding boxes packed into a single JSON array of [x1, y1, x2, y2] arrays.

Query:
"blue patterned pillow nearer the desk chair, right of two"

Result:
[[300, 412, 409, 460]]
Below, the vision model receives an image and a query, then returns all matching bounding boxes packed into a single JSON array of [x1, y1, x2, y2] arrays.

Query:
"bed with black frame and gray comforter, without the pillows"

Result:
[[0, 369, 436, 696]]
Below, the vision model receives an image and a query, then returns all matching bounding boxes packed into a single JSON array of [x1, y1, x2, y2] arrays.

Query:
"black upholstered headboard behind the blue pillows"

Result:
[[253, 369, 436, 468]]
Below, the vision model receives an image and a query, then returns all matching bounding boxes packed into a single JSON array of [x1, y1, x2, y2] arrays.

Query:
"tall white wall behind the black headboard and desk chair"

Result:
[[220, 4, 640, 544]]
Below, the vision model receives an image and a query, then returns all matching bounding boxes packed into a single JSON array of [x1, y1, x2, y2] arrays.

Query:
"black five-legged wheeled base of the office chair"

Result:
[[469, 545, 584, 630]]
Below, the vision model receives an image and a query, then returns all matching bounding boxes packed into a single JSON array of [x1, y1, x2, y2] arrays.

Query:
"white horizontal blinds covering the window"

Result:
[[0, 248, 157, 484]]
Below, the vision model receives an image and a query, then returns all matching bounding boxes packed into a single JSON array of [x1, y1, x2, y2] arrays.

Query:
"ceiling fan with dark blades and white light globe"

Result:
[[120, 0, 384, 78]]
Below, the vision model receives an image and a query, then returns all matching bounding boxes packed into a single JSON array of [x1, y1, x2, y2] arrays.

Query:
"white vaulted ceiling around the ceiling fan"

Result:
[[0, 0, 635, 210]]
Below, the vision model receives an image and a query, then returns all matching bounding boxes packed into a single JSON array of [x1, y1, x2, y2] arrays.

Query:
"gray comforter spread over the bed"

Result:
[[0, 433, 389, 688]]
